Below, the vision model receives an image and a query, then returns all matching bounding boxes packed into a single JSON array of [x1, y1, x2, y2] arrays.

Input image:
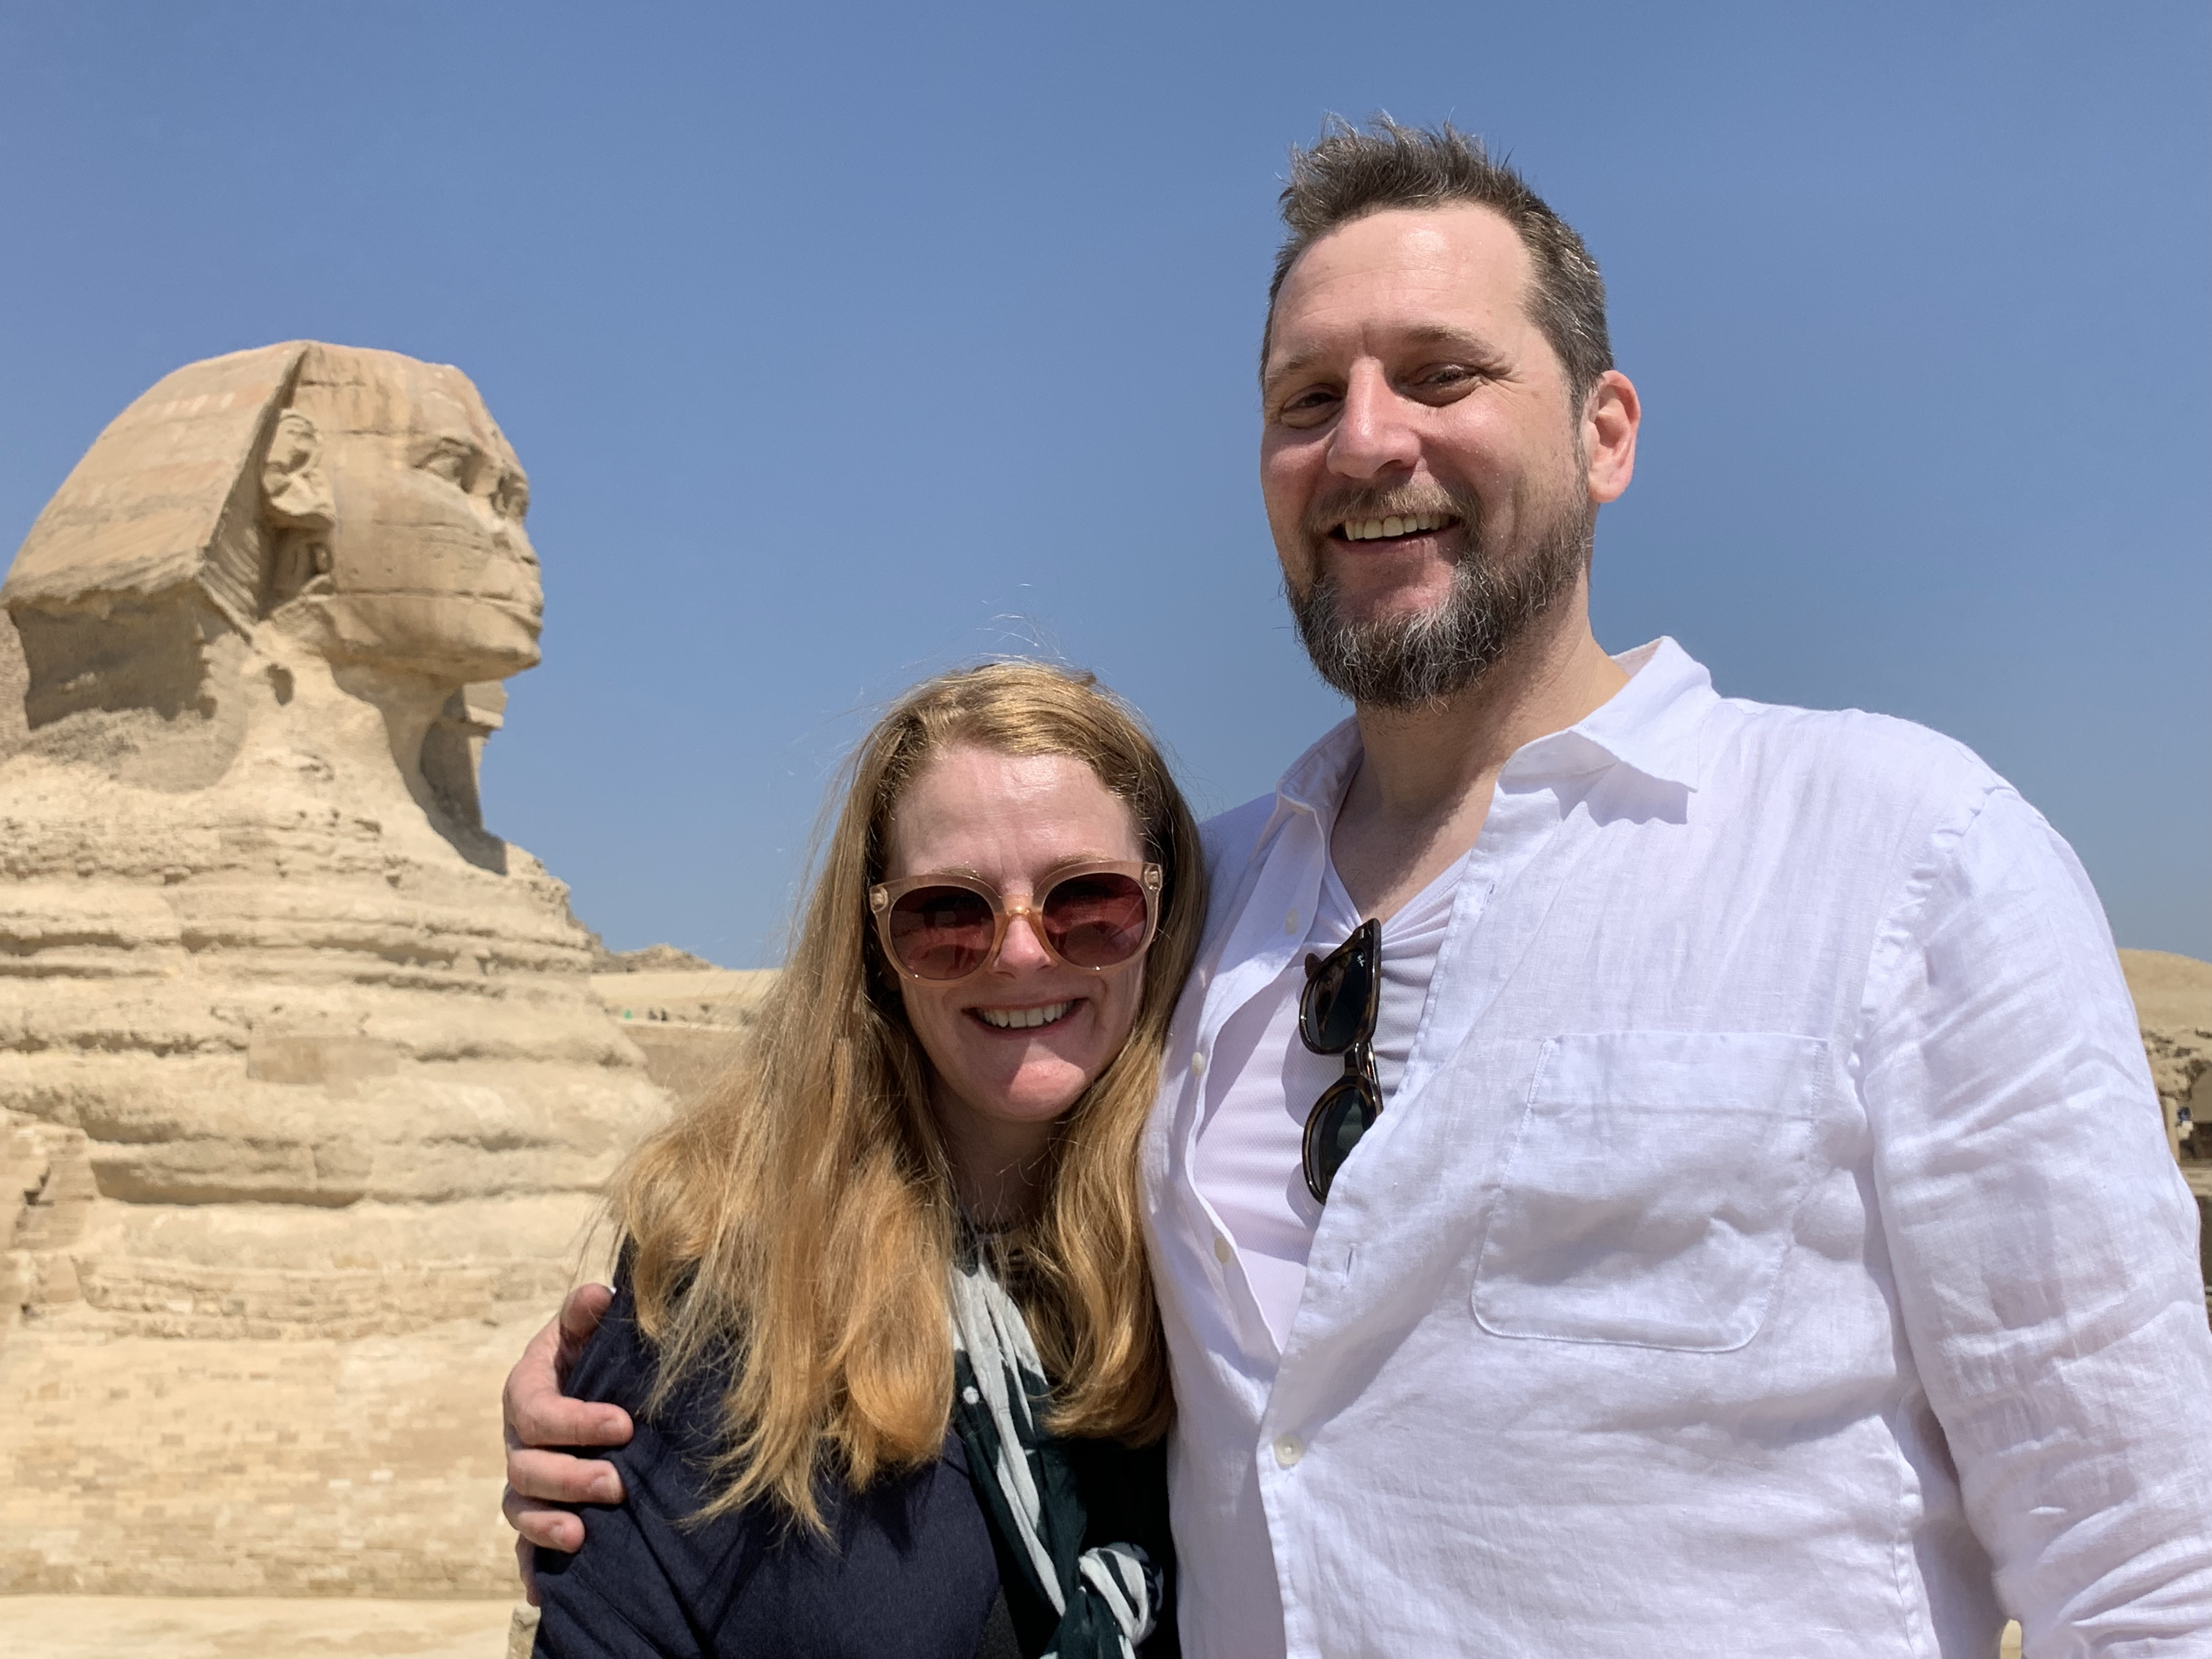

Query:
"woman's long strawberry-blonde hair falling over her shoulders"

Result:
[[613, 664, 1205, 1528]]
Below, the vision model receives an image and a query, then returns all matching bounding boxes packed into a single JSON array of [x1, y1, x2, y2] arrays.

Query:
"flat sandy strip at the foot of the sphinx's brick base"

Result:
[[0, 1595, 526, 1659]]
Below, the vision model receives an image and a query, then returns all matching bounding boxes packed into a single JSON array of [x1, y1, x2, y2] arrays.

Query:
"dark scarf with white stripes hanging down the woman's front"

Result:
[[951, 1250, 1161, 1659]]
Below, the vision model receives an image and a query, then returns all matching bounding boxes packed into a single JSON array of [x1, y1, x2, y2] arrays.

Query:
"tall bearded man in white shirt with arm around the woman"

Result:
[[511, 122, 2212, 1659]]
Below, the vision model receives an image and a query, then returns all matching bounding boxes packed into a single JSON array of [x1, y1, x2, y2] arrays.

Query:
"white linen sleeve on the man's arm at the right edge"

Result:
[[1856, 785, 2212, 1659]]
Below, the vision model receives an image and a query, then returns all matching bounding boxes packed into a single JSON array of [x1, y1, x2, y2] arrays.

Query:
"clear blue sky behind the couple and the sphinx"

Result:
[[0, 0, 2212, 964]]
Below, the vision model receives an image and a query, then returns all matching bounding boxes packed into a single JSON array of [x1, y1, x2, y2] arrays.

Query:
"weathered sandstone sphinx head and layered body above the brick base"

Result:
[[0, 343, 666, 1336]]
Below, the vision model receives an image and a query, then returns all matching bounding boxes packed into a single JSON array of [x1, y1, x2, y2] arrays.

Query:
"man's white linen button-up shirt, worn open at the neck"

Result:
[[1142, 639, 2212, 1659]]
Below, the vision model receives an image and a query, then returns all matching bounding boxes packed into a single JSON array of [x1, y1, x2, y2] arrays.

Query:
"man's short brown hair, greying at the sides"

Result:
[[1261, 115, 1612, 409]]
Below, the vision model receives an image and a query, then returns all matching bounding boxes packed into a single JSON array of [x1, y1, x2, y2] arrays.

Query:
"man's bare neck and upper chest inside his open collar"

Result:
[[1329, 586, 1628, 920]]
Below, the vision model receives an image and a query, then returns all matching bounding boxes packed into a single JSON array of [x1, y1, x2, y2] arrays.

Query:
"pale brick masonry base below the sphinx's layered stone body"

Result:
[[0, 1310, 542, 1601]]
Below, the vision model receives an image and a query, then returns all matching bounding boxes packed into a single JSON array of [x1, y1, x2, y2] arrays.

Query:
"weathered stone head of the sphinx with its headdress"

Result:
[[0, 343, 544, 728]]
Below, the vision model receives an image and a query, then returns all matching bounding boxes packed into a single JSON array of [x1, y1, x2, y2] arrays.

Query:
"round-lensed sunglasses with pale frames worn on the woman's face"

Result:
[[867, 862, 1161, 984]]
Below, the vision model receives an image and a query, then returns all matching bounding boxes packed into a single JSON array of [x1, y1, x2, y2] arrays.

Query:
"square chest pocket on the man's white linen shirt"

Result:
[[1475, 1031, 1827, 1354]]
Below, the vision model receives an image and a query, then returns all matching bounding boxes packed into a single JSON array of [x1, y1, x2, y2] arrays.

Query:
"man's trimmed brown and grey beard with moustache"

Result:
[[1285, 484, 1597, 710]]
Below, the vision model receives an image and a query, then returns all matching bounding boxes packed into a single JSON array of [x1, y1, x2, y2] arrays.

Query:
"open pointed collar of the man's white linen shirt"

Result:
[[1269, 635, 1721, 832]]
